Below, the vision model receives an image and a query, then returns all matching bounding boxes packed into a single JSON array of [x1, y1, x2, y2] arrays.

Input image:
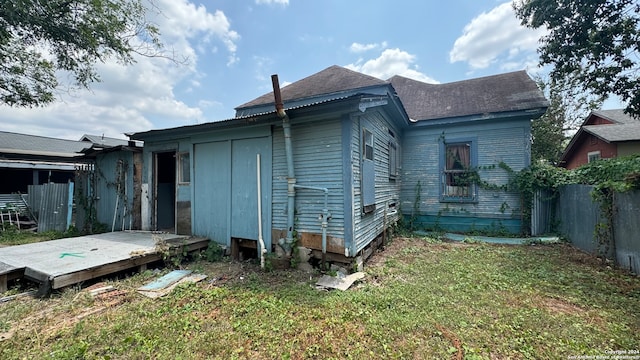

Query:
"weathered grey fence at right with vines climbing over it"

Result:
[[548, 185, 640, 274]]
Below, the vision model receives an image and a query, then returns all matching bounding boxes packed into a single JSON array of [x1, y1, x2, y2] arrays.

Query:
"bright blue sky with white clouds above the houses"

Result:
[[0, 0, 620, 140]]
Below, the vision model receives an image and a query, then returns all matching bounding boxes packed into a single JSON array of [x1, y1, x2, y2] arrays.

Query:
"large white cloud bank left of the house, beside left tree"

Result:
[[0, 0, 240, 140]]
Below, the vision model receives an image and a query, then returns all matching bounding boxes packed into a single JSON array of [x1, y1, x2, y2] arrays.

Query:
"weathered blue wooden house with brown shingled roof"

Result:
[[131, 66, 546, 261]]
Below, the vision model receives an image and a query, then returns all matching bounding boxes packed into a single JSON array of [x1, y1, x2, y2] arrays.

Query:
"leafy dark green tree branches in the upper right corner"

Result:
[[514, 0, 640, 116]]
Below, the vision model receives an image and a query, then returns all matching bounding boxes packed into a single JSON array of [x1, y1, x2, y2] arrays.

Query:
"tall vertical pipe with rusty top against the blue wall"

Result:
[[271, 74, 296, 253]]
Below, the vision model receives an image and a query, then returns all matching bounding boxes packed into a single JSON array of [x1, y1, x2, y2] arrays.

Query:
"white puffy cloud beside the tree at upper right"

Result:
[[449, 1, 546, 70]]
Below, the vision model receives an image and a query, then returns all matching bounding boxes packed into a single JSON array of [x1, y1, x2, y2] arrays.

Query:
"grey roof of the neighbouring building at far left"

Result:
[[0, 131, 91, 158]]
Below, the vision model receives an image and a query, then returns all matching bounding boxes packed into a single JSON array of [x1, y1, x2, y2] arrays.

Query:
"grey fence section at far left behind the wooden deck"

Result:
[[28, 182, 73, 232]]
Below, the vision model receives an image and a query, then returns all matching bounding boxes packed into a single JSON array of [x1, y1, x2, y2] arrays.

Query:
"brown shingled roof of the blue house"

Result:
[[128, 65, 548, 140]]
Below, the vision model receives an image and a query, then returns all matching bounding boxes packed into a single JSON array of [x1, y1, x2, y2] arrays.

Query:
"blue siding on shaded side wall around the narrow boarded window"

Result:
[[350, 110, 403, 256]]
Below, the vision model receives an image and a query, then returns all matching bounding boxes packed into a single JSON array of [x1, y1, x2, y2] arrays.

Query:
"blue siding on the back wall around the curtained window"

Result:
[[401, 120, 530, 228]]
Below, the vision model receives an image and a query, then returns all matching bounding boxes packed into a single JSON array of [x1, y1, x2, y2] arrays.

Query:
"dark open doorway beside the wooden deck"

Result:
[[155, 151, 176, 233]]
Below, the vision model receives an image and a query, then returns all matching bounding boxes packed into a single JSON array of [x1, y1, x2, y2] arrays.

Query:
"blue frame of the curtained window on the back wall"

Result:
[[439, 137, 478, 203]]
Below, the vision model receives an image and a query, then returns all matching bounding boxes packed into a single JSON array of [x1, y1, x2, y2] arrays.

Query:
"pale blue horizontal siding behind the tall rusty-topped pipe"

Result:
[[272, 118, 344, 241]]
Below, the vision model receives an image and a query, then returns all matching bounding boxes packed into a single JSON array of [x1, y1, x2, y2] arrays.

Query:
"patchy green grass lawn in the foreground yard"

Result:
[[0, 238, 640, 359]]
